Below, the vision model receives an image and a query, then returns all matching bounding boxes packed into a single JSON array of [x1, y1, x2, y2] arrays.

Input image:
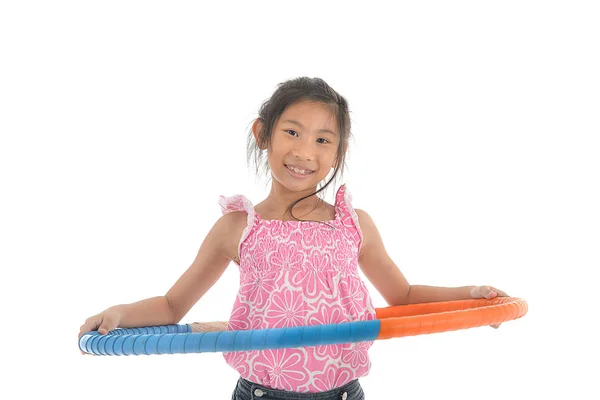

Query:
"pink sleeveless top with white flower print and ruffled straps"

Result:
[[219, 185, 376, 392]]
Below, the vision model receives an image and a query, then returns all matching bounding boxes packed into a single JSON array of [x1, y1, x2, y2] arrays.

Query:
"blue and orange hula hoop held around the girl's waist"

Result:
[[79, 297, 527, 356]]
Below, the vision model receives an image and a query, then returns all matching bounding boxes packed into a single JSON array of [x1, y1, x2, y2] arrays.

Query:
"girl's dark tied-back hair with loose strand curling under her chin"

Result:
[[247, 77, 351, 222]]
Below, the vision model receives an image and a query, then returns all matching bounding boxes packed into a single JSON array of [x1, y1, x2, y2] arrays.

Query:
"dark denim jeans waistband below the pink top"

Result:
[[231, 377, 365, 400]]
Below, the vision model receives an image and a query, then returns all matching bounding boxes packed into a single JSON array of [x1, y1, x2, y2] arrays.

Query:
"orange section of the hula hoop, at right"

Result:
[[375, 297, 527, 340]]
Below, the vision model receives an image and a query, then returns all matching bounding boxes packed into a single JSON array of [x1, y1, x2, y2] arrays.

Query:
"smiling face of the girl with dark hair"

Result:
[[267, 101, 340, 191]]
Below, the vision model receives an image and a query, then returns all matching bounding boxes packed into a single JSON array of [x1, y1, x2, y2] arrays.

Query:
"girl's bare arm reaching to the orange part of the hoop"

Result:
[[355, 209, 506, 306]]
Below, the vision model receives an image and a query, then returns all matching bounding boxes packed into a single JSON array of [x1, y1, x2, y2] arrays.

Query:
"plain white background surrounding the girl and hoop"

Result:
[[0, 1, 600, 400]]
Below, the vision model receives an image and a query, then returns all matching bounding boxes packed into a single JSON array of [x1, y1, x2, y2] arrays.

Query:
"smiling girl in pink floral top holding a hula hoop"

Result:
[[80, 77, 506, 400]]
